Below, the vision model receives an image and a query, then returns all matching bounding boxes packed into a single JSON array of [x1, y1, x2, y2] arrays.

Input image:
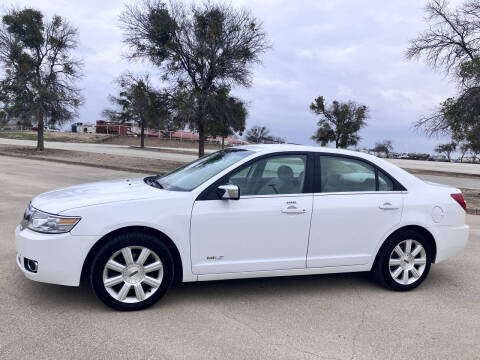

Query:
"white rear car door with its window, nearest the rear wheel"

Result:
[[307, 155, 403, 268]]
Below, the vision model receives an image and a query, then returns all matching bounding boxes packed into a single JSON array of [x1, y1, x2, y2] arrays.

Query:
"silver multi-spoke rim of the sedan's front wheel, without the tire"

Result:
[[103, 246, 163, 303]]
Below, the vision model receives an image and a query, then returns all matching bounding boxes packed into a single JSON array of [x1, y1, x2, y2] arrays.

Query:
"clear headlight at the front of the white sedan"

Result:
[[21, 205, 80, 234]]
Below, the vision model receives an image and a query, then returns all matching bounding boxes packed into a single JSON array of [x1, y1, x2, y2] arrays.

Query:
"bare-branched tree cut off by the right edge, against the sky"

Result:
[[406, 0, 480, 141]]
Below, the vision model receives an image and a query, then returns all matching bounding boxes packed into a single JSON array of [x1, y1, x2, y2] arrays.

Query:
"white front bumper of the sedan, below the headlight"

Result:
[[15, 226, 97, 286]]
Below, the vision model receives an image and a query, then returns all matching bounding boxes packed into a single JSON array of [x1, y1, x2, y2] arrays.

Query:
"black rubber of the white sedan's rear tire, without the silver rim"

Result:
[[372, 230, 433, 291]]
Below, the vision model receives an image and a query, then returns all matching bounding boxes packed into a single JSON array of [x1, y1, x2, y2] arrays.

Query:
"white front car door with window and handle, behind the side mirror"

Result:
[[191, 153, 313, 274]]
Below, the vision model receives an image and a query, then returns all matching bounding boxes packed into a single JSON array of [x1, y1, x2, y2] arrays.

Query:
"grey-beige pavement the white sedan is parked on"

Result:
[[0, 156, 480, 359]]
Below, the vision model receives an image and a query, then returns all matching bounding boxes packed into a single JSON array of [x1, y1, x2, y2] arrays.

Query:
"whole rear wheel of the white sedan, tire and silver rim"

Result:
[[372, 230, 433, 291]]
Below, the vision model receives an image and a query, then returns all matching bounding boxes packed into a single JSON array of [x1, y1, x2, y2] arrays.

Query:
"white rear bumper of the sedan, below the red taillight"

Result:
[[435, 225, 470, 263]]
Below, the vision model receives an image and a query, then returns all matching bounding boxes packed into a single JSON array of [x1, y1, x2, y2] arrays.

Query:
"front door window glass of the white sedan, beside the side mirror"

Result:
[[228, 155, 307, 196]]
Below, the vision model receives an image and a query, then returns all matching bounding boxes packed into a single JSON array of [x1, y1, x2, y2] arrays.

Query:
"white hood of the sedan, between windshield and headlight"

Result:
[[32, 179, 167, 214]]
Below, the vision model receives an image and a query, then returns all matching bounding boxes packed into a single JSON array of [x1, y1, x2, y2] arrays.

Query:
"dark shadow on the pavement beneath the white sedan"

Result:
[[13, 269, 449, 312]]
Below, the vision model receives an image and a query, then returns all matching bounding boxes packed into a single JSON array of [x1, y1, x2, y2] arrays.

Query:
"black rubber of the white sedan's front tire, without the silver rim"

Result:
[[90, 232, 174, 311]]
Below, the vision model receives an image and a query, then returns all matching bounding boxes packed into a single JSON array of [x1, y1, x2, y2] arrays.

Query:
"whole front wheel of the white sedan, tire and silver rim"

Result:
[[90, 232, 173, 311]]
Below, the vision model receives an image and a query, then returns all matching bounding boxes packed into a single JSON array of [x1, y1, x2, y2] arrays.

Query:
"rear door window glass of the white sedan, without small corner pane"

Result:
[[320, 156, 376, 192]]
